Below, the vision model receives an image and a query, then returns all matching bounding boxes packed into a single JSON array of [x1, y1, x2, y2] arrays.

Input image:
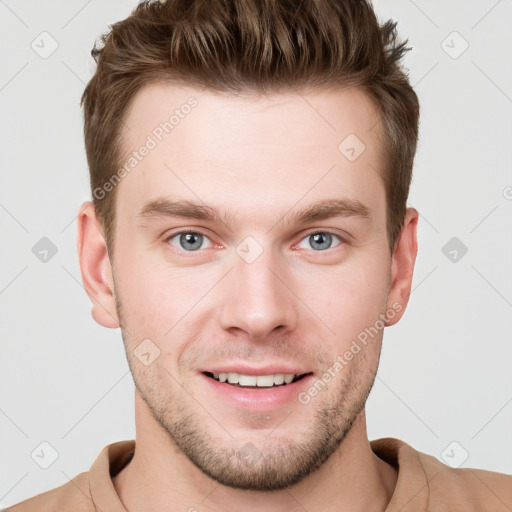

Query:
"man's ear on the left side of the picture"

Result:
[[77, 201, 119, 329]]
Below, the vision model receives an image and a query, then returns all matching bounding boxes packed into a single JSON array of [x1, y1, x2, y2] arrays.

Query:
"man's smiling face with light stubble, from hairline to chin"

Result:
[[108, 84, 391, 490]]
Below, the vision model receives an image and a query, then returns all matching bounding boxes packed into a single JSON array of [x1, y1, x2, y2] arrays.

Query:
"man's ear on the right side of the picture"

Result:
[[386, 208, 419, 326]]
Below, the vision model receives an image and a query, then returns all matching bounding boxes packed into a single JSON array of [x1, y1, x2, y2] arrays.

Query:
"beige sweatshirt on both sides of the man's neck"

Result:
[[6, 437, 512, 512]]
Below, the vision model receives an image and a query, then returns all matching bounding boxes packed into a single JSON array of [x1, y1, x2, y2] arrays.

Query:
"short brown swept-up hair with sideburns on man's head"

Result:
[[80, 0, 419, 258]]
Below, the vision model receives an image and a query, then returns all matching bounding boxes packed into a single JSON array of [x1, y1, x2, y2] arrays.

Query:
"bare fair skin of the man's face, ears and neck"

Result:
[[78, 84, 418, 512]]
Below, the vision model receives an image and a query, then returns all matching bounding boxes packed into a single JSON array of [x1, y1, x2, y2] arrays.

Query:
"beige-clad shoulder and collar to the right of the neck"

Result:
[[371, 438, 512, 512]]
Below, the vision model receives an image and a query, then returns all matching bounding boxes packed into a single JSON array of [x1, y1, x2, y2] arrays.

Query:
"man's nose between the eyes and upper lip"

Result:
[[220, 246, 298, 340]]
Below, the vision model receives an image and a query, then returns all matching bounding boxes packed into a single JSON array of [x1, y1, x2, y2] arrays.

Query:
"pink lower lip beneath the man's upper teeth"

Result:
[[201, 374, 313, 411]]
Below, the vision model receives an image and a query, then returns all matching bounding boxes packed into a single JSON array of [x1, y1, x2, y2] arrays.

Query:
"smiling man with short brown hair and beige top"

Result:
[[5, 0, 512, 512]]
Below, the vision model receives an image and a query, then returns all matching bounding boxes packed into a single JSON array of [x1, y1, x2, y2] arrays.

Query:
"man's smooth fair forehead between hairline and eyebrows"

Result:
[[117, 84, 384, 228]]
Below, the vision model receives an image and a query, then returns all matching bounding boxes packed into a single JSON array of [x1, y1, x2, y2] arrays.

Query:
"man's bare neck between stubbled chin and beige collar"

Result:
[[112, 393, 398, 512]]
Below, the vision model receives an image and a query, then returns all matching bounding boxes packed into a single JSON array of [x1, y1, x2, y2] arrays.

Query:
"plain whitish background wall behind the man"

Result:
[[0, 0, 512, 507]]
